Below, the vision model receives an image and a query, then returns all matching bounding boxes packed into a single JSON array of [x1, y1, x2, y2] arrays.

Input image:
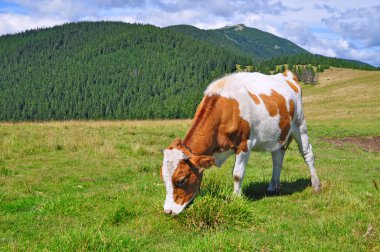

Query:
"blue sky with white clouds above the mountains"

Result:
[[0, 0, 380, 66]]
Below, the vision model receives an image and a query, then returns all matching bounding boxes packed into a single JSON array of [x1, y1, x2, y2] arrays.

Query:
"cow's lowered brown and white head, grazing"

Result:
[[161, 139, 215, 215]]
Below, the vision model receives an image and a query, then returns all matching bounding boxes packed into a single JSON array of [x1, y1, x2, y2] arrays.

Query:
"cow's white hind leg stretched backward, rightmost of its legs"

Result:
[[292, 116, 321, 192]]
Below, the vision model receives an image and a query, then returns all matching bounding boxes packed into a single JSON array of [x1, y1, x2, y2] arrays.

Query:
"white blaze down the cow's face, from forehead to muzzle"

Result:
[[162, 149, 189, 214]]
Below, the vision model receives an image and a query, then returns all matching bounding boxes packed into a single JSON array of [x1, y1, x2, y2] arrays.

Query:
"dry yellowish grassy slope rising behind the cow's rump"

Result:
[[303, 68, 380, 126]]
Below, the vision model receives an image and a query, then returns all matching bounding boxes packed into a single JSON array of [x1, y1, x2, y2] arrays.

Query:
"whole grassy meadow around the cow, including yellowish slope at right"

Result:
[[0, 69, 380, 251]]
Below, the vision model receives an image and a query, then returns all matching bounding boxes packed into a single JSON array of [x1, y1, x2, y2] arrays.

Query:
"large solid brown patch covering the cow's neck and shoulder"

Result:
[[183, 95, 250, 155]]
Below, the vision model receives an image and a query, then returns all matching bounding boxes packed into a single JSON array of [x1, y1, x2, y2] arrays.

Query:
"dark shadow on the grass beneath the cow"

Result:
[[243, 178, 311, 201]]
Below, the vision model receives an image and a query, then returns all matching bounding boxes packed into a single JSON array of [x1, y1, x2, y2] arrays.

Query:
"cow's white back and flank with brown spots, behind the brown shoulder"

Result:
[[205, 71, 302, 151]]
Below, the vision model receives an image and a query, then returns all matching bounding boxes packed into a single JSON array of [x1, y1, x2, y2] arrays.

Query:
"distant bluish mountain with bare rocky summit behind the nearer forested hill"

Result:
[[166, 24, 309, 61]]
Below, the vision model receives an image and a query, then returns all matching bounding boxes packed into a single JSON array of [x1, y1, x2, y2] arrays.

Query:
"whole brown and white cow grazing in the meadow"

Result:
[[161, 71, 320, 215]]
